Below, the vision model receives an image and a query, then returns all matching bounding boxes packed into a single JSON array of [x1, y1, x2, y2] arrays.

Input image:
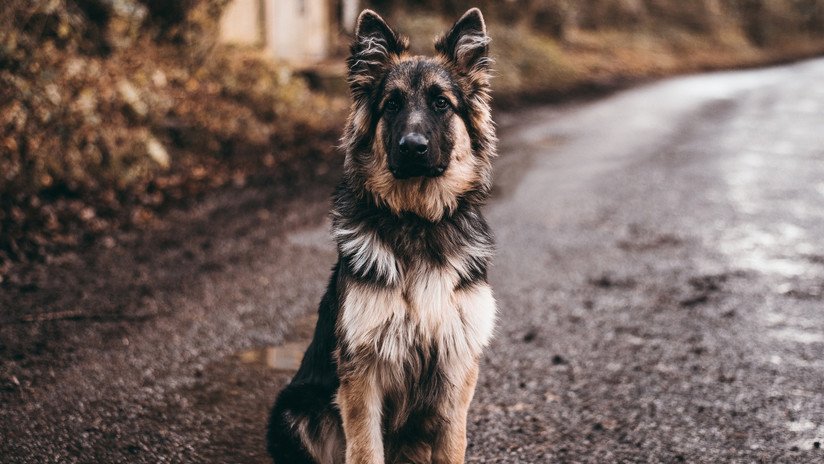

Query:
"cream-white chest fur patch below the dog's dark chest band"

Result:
[[341, 265, 496, 364]]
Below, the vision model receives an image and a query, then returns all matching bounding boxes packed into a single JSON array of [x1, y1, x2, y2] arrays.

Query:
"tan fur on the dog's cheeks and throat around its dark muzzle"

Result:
[[366, 117, 479, 222]]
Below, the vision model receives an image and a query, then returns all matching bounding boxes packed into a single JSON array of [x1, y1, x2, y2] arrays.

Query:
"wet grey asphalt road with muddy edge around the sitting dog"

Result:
[[0, 60, 824, 463]]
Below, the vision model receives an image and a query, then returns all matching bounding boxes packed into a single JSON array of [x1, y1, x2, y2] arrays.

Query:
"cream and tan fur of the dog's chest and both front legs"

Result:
[[338, 267, 496, 463]]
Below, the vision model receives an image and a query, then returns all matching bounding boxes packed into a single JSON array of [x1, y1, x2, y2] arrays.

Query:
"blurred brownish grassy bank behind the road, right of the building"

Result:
[[370, 0, 824, 105]]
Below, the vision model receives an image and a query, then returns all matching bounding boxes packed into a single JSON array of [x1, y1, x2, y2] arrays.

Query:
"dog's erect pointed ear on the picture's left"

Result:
[[347, 10, 409, 97]]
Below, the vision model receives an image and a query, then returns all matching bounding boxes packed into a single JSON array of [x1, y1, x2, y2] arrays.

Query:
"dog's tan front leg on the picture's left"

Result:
[[338, 369, 384, 464]]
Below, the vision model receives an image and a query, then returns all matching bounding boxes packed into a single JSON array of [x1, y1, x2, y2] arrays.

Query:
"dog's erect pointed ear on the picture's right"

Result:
[[435, 8, 491, 72]]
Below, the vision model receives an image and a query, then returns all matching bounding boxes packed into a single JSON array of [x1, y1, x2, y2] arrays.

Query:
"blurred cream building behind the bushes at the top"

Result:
[[220, 0, 360, 66]]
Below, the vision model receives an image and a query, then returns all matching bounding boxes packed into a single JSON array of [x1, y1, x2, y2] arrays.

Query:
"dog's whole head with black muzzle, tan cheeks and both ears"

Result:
[[344, 8, 496, 221]]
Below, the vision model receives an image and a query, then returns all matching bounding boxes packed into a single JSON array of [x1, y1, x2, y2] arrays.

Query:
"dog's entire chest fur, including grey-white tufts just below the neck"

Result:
[[335, 207, 496, 376]]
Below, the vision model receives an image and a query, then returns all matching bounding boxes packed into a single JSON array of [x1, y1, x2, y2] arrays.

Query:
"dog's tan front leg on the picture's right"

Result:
[[432, 361, 478, 464]]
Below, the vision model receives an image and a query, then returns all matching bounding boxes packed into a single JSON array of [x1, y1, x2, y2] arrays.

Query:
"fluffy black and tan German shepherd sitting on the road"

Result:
[[268, 9, 497, 464]]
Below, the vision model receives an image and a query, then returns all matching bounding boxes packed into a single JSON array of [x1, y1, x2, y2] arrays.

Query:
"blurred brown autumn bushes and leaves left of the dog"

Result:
[[0, 0, 345, 282]]
